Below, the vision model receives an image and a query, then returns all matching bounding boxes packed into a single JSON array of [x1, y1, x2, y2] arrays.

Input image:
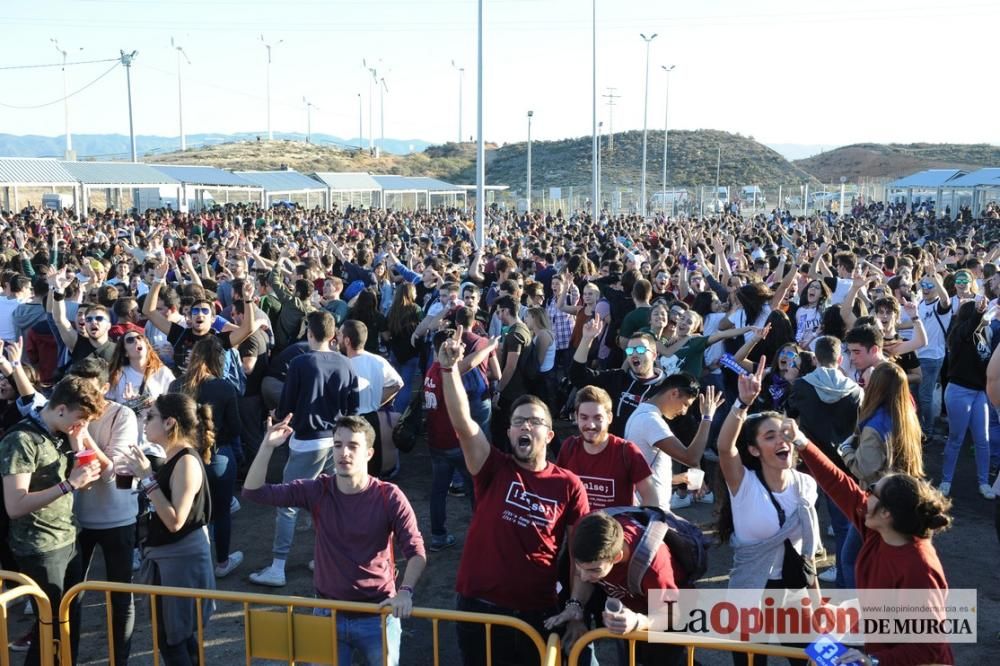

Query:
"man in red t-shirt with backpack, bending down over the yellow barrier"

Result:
[[545, 511, 686, 666]]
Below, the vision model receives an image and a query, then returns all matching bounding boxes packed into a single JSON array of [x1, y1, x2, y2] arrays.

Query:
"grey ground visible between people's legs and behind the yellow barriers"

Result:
[[9, 424, 1000, 666]]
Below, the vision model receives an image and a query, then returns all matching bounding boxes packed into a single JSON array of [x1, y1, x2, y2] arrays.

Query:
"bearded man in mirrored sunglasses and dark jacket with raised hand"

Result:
[[569, 318, 666, 437]]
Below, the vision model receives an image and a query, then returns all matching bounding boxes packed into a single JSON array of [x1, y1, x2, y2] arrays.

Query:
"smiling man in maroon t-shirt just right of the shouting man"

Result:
[[556, 386, 656, 510]]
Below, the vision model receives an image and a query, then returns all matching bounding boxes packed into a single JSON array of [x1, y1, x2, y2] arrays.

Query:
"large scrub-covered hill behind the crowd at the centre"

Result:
[[141, 130, 810, 192]]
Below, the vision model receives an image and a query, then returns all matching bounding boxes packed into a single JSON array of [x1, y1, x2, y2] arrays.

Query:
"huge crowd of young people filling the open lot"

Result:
[[0, 198, 1000, 665]]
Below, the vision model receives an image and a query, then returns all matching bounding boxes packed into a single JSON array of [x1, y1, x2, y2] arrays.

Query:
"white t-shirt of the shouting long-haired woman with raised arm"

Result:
[[729, 467, 818, 580]]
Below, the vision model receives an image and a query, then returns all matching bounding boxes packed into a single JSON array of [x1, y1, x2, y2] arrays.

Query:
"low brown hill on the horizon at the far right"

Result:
[[793, 143, 1000, 183]]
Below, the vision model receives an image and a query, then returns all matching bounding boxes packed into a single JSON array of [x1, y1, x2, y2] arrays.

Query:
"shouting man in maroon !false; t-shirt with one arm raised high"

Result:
[[438, 327, 590, 666]]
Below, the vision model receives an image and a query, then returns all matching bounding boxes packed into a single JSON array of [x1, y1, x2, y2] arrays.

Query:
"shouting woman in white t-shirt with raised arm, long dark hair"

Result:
[[719, 358, 820, 664]]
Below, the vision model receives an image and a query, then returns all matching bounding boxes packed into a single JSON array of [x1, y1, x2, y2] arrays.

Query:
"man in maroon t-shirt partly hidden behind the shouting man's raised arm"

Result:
[[424, 328, 497, 553]]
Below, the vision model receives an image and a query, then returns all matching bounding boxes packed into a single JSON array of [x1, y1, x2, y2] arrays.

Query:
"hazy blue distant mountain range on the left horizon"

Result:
[[0, 132, 431, 160]]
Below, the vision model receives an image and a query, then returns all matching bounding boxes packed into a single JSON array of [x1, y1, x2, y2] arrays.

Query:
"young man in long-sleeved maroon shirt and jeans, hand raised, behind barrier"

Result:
[[243, 414, 427, 666]]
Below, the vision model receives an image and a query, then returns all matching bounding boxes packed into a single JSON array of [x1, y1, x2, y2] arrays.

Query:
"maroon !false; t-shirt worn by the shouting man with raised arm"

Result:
[[455, 447, 590, 611]]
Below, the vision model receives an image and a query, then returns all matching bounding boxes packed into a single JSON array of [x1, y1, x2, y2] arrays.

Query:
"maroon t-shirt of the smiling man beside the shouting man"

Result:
[[556, 435, 653, 511]]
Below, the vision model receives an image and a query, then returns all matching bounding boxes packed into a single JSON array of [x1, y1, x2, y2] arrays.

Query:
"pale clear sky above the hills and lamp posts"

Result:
[[0, 0, 1000, 146]]
